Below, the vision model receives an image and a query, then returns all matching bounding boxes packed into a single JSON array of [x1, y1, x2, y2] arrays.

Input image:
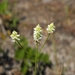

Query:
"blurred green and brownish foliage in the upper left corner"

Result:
[[0, 0, 18, 30]]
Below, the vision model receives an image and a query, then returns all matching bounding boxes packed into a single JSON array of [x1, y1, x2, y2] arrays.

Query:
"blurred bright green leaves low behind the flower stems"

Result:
[[15, 37, 50, 74]]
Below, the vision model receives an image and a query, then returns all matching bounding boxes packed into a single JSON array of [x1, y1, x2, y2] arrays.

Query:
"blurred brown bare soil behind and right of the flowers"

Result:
[[0, 0, 75, 75]]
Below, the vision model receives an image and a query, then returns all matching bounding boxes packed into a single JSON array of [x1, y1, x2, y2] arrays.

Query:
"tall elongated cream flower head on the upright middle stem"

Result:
[[33, 24, 42, 42]]
